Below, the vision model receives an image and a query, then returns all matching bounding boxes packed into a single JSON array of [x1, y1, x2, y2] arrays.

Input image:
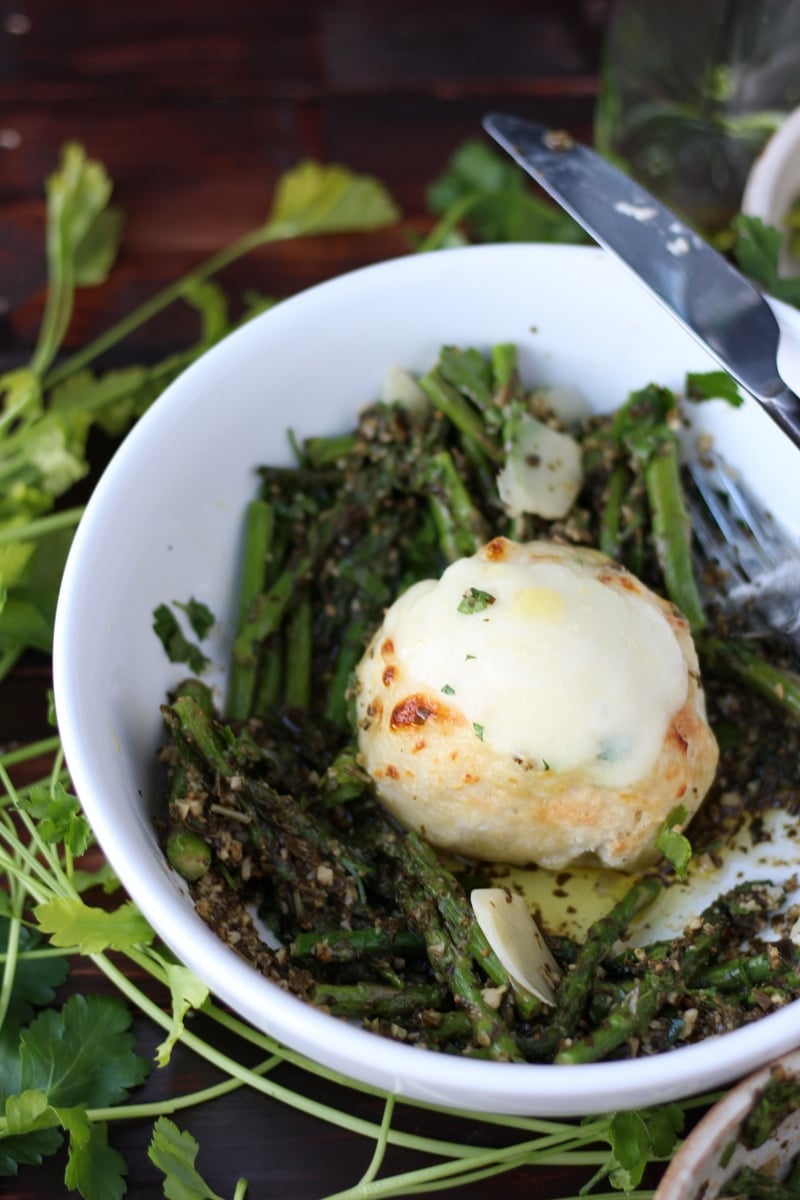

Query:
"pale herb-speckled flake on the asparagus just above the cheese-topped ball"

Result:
[[498, 413, 583, 521]]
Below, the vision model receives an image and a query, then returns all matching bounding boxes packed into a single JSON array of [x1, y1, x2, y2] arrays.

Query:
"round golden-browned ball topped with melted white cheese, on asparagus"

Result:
[[356, 538, 717, 869]]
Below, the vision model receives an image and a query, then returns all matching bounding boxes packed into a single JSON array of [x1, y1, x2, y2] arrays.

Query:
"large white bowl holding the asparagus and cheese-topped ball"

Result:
[[54, 245, 800, 1116]]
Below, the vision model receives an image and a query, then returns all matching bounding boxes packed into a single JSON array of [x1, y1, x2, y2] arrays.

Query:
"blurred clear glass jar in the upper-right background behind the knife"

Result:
[[595, 0, 800, 236]]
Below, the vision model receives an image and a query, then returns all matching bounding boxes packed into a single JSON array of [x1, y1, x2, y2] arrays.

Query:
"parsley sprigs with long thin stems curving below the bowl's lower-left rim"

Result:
[[0, 738, 699, 1200]]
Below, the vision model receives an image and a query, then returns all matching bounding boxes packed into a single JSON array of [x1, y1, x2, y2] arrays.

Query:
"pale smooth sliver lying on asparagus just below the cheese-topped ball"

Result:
[[470, 888, 561, 1004]]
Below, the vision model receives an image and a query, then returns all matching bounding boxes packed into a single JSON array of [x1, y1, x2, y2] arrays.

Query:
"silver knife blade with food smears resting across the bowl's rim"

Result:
[[483, 114, 800, 446]]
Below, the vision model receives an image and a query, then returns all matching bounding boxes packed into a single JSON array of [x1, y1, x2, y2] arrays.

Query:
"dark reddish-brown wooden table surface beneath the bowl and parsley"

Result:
[[0, 0, 681, 1200]]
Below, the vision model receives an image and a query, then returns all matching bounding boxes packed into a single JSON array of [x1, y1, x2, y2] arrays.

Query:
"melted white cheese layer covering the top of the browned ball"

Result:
[[384, 544, 688, 787]]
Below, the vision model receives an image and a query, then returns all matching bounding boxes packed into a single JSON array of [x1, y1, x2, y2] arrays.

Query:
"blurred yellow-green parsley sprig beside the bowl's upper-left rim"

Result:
[[0, 143, 399, 679]]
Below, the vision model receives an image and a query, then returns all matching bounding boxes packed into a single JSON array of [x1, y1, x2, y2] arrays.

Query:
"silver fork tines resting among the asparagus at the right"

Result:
[[686, 457, 800, 653]]
